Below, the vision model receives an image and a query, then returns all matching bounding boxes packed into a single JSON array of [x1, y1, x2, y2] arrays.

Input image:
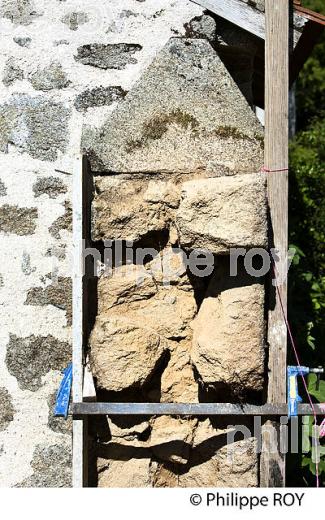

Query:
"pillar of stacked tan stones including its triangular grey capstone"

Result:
[[86, 37, 267, 487]]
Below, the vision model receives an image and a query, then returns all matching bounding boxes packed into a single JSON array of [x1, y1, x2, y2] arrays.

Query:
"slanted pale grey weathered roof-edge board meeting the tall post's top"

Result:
[[192, 0, 307, 45]]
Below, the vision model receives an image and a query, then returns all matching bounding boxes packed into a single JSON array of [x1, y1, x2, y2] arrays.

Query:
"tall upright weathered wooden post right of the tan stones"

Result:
[[260, 0, 289, 487]]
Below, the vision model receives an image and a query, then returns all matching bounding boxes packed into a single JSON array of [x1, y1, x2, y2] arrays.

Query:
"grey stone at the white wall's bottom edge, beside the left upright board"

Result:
[[16, 443, 72, 488]]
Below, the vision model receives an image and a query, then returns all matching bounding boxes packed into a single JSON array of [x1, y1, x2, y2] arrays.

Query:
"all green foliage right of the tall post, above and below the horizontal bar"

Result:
[[289, 0, 325, 486]]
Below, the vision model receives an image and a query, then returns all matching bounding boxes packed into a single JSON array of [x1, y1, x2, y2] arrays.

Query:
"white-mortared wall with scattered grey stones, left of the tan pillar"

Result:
[[0, 0, 205, 486]]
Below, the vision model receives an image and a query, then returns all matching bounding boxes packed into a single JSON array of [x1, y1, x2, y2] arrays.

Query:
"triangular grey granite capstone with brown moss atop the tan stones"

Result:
[[83, 38, 263, 174]]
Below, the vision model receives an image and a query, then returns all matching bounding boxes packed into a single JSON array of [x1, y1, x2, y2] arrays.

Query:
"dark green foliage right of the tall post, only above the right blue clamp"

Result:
[[289, 120, 325, 364]]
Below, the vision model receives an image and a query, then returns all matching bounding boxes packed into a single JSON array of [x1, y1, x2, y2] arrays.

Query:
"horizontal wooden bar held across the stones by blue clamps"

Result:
[[72, 402, 324, 417]]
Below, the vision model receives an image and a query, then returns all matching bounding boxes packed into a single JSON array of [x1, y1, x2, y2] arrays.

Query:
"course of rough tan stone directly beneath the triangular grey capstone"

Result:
[[92, 174, 267, 254]]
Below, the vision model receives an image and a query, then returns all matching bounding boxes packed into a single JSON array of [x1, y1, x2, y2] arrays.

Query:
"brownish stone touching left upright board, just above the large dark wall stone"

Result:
[[25, 276, 72, 326]]
